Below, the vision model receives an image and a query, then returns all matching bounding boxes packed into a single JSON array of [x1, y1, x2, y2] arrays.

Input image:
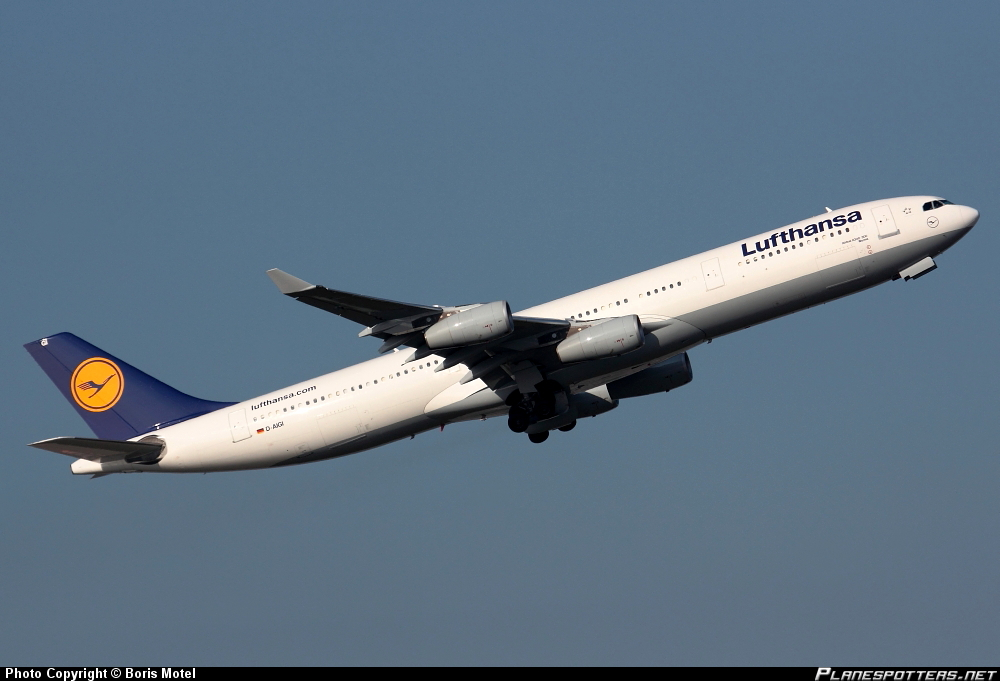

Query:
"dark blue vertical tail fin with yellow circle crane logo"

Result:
[[24, 333, 234, 440]]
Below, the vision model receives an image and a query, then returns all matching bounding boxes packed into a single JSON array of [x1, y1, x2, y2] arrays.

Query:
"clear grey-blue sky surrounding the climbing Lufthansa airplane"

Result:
[[0, 2, 1000, 665]]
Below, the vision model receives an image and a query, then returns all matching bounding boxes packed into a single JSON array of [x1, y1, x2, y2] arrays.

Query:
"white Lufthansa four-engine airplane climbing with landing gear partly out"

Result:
[[24, 196, 979, 477]]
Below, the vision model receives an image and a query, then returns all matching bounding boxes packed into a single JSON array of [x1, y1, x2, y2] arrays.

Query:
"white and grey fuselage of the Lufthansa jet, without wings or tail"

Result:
[[73, 196, 978, 473]]
